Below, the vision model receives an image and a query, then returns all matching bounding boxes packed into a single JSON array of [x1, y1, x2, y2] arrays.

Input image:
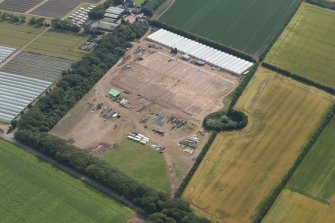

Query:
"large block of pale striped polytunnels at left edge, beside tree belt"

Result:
[[0, 71, 51, 123]]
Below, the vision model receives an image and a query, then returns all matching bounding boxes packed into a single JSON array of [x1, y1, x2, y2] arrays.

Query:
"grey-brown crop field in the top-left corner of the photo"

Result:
[[0, 0, 42, 12]]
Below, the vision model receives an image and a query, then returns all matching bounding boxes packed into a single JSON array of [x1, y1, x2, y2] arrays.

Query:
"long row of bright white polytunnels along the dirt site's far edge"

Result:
[[147, 29, 254, 75]]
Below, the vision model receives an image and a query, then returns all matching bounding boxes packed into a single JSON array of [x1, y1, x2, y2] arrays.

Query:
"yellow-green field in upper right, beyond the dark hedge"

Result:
[[265, 3, 335, 88]]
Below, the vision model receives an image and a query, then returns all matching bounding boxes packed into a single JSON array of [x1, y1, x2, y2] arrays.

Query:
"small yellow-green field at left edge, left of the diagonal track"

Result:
[[0, 22, 45, 49]]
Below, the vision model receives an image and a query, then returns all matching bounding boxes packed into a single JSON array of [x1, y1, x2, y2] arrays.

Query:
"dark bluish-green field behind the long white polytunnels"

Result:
[[160, 0, 299, 56]]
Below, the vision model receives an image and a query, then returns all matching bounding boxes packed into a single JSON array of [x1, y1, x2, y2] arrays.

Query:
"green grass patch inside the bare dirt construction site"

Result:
[[103, 140, 170, 192]]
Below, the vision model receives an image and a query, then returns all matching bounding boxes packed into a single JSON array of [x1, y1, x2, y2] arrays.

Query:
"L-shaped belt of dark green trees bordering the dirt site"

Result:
[[12, 23, 210, 223]]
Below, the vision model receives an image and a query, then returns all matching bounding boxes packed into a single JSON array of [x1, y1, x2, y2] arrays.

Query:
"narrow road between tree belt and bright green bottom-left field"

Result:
[[0, 134, 145, 218]]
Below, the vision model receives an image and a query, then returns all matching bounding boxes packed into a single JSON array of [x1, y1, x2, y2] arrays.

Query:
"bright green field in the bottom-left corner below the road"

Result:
[[0, 140, 134, 223]]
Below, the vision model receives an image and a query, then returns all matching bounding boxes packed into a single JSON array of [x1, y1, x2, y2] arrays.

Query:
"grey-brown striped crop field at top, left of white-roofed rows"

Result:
[[31, 0, 90, 19]]
